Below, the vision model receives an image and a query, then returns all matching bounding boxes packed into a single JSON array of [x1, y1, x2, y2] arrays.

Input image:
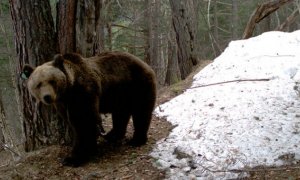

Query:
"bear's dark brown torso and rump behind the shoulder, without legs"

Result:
[[86, 51, 156, 112]]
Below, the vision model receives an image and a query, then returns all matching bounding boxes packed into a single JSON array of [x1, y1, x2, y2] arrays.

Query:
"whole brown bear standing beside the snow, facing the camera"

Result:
[[22, 51, 156, 166]]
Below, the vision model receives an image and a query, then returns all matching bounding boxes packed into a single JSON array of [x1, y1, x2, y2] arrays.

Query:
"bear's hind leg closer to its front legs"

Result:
[[104, 112, 130, 142]]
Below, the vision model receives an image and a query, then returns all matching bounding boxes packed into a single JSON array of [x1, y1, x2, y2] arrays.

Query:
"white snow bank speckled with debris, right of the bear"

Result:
[[151, 31, 300, 179]]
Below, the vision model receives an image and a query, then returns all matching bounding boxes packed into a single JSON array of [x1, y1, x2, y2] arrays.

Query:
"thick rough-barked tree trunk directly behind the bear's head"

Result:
[[10, 0, 67, 151]]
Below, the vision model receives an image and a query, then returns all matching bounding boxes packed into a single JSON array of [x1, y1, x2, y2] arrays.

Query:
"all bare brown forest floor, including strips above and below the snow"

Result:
[[0, 61, 300, 180]]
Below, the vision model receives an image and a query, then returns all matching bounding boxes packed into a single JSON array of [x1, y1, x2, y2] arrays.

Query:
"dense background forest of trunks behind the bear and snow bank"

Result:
[[0, 0, 300, 169]]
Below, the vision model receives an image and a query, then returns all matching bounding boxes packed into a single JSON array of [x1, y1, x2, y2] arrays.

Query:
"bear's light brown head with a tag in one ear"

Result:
[[21, 55, 68, 105]]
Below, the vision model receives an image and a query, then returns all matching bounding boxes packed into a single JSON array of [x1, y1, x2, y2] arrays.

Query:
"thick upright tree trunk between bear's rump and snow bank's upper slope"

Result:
[[169, 0, 198, 79]]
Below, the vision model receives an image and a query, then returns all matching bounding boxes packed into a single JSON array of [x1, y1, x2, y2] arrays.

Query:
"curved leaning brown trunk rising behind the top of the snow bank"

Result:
[[243, 0, 293, 39]]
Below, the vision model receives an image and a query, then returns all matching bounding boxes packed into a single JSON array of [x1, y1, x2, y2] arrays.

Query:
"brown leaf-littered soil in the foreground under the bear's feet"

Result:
[[0, 117, 171, 180]]
